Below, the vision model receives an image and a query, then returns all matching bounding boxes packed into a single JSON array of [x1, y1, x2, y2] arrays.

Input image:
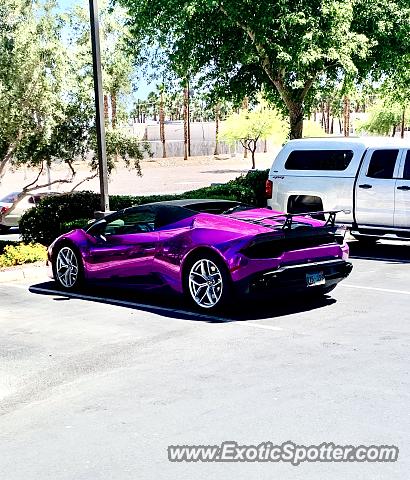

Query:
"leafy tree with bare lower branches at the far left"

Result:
[[0, 0, 148, 224]]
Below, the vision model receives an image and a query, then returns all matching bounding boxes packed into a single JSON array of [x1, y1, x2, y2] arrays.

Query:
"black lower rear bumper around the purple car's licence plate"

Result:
[[236, 259, 353, 296]]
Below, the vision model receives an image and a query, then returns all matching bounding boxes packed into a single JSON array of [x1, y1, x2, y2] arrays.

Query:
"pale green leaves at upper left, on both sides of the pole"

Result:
[[0, 0, 149, 189]]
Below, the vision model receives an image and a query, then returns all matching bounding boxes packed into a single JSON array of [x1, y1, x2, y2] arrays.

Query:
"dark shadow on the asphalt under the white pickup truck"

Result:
[[349, 241, 410, 264]]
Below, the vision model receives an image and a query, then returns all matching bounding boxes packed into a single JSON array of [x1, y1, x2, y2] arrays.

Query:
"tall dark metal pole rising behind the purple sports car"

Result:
[[89, 0, 110, 212]]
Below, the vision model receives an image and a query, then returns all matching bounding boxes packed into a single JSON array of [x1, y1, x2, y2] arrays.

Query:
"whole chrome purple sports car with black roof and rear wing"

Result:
[[48, 200, 352, 309]]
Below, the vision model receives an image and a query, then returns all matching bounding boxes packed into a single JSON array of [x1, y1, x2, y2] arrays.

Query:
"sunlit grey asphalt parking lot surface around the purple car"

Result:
[[0, 242, 410, 480]]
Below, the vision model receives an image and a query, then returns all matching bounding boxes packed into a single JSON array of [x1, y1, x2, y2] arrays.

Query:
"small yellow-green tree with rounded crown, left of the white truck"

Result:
[[221, 107, 287, 170]]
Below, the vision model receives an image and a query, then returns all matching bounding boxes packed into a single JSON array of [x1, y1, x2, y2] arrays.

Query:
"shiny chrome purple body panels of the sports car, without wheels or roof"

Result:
[[49, 209, 349, 292]]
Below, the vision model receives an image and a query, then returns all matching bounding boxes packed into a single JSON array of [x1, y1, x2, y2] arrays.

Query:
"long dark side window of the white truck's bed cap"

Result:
[[285, 150, 353, 171]]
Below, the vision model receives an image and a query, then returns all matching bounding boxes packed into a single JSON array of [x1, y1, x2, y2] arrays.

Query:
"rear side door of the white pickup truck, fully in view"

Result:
[[355, 148, 400, 227]]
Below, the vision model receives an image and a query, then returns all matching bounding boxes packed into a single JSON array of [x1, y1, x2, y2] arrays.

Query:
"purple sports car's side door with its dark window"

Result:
[[86, 207, 158, 283]]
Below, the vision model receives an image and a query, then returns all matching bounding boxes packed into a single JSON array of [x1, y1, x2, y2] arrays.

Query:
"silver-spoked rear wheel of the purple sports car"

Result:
[[184, 254, 231, 310]]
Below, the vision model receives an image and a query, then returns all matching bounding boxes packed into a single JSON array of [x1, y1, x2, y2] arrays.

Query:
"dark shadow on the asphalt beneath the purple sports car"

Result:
[[29, 281, 336, 323]]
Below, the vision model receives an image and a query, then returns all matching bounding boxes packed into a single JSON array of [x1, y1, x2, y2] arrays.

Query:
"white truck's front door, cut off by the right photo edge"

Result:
[[394, 150, 410, 229]]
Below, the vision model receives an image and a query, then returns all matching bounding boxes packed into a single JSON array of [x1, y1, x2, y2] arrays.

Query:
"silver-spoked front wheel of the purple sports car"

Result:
[[53, 245, 83, 290]]
